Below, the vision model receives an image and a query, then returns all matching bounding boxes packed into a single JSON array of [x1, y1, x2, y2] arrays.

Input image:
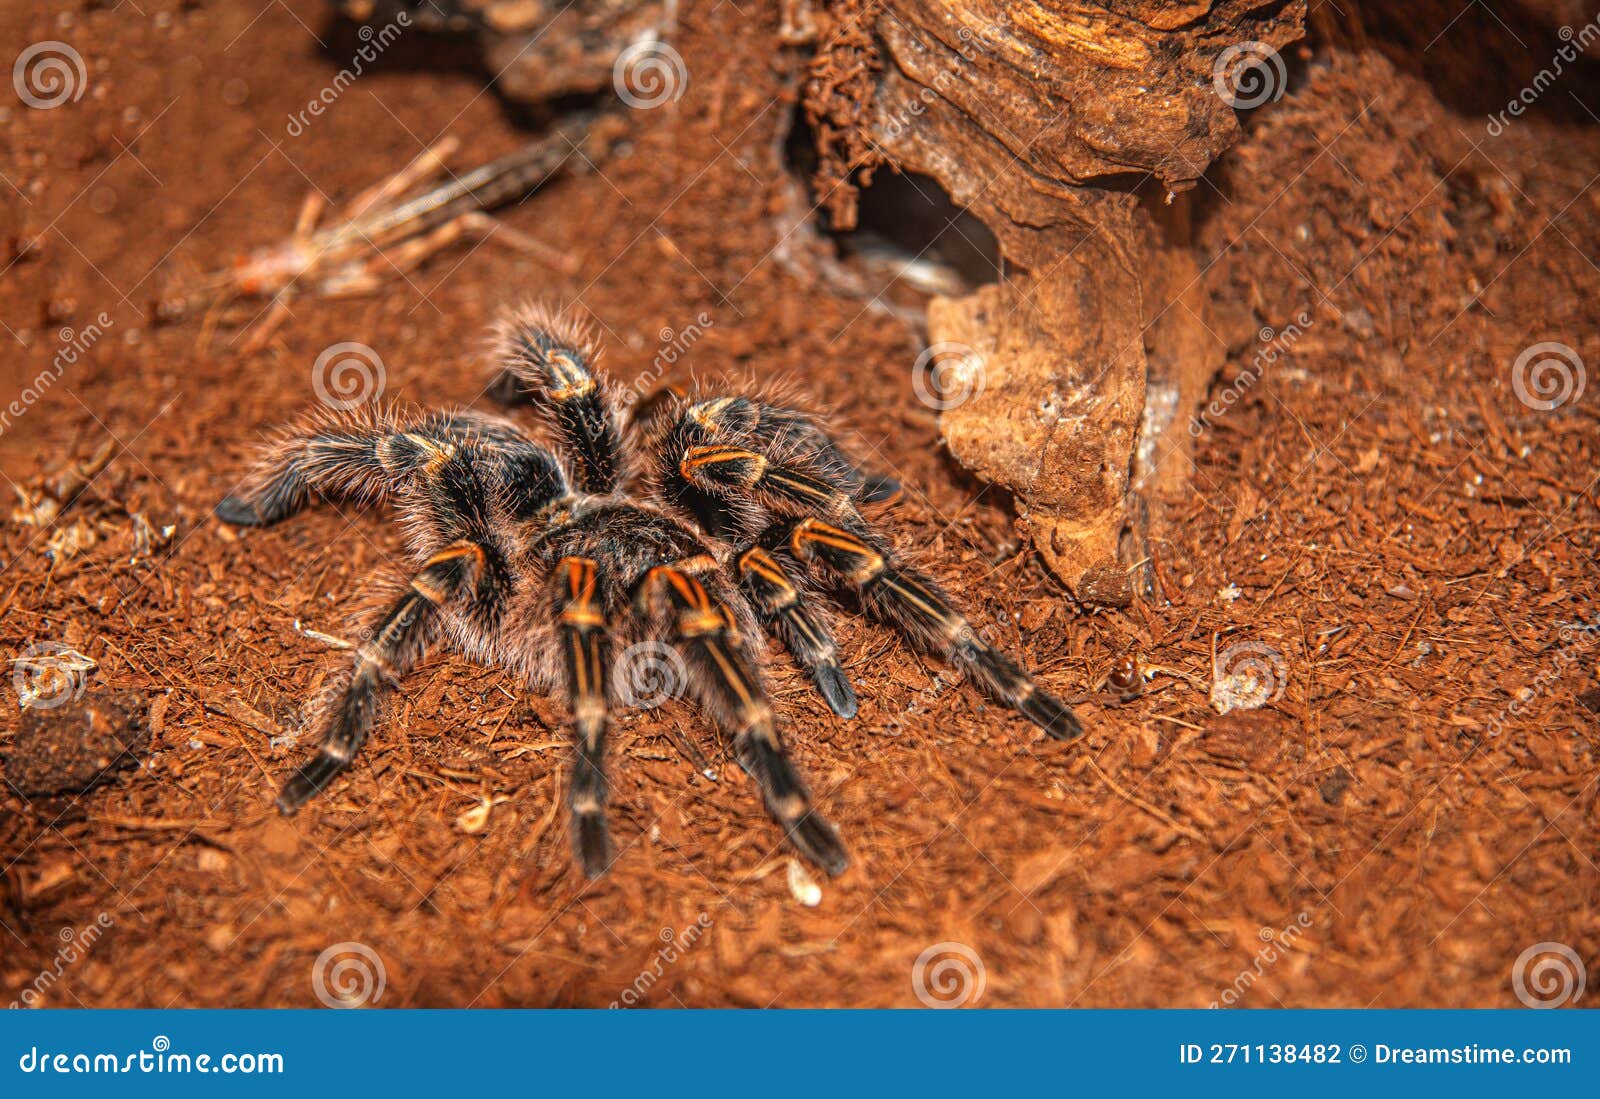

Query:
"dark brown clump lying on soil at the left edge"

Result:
[[5, 691, 150, 797]]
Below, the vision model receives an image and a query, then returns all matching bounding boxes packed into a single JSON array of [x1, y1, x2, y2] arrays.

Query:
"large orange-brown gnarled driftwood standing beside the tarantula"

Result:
[[806, 0, 1306, 603]]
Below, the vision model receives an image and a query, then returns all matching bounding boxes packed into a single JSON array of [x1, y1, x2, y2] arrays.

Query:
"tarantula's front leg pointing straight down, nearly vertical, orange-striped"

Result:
[[550, 557, 616, 878]]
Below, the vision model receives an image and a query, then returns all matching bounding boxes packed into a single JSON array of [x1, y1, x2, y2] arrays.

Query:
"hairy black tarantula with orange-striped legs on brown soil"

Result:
[[216, 307, 1082, 877]]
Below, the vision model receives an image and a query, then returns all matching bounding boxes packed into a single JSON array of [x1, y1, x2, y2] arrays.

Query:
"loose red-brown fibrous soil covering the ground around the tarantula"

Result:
[[0, 0, 1600, 1006]]
